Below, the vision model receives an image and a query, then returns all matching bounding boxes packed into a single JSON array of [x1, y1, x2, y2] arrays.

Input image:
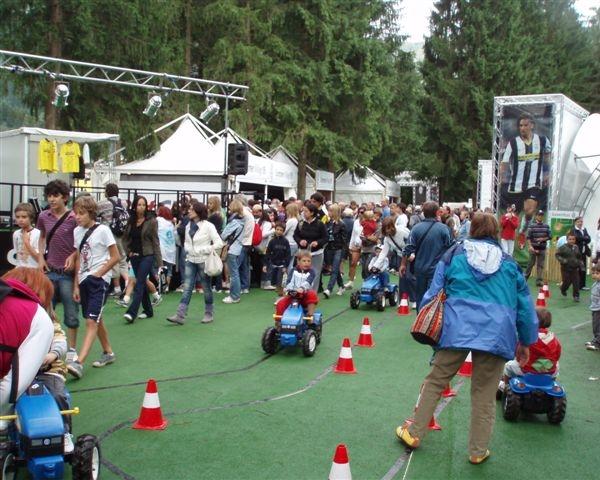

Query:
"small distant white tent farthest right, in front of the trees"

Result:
[[335, 167, 400, 203]]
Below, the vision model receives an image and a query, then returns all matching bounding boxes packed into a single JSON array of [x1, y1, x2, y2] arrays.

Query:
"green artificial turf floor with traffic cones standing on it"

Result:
[[54, 278, 600, 479]]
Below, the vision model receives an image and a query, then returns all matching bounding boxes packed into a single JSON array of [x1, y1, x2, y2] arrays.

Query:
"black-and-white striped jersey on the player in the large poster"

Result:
[[502, 134, 551, 193]]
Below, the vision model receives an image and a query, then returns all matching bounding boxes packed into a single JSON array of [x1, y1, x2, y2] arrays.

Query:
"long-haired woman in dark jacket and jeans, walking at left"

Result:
[[123, 195, 163, 323]]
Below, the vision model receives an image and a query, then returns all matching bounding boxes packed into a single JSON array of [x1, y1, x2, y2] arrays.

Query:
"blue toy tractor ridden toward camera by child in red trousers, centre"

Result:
[[262, 290, 323, 357]]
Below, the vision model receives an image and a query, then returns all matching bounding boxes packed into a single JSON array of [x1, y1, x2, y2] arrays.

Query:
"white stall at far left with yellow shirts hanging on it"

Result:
[[0, 127, 119, 214]]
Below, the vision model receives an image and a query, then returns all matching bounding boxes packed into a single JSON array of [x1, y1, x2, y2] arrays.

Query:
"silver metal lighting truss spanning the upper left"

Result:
[[0, 50, 248, 101]]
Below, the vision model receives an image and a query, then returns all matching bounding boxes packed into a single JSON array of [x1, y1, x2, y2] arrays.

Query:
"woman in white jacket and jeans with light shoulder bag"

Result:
[[167, 202, 223, 325]]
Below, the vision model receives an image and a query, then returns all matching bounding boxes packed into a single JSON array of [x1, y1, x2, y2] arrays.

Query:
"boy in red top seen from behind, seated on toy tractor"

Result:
[[498, 307, 561, 390]]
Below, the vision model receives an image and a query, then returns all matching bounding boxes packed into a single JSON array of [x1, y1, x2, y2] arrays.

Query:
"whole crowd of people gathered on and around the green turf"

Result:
[[0, 180, 600, 463]]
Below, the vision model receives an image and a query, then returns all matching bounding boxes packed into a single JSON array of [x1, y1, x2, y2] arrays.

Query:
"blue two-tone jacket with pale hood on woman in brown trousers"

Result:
[[421, 239, 538, 360]]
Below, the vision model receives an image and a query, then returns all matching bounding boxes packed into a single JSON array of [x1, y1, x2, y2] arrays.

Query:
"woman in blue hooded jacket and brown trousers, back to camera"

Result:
[[396, 213, 538, 464]]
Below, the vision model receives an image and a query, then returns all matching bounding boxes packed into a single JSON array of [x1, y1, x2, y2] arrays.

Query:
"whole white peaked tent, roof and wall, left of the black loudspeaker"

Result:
[[115, 113, 225, 192]]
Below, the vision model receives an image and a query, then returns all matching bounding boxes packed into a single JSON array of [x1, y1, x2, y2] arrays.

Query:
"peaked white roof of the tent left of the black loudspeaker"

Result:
[[116, 114, 223, 175]]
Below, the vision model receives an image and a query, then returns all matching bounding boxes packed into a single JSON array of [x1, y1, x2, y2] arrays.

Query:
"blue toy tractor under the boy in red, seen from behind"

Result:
[[502, 373, 567, 424]]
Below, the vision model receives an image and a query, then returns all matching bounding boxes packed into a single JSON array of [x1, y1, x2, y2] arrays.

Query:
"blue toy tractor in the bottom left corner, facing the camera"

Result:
[[0, 383, 100, 480]]
